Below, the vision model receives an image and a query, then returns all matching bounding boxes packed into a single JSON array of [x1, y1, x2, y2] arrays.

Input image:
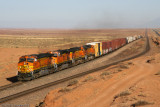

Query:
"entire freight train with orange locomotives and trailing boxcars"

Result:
[[17, 35, 142, 80]]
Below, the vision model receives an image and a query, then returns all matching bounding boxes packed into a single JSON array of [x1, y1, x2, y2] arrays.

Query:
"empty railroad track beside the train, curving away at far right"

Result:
[[0, 30, 150, 103]]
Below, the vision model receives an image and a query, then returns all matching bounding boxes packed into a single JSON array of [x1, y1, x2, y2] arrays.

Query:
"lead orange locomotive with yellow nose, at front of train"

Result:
[[17, 53, 52, 80]]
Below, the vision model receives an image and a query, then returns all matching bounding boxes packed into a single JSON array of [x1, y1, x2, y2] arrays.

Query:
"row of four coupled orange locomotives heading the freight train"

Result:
[[17, 45, 95, 80]]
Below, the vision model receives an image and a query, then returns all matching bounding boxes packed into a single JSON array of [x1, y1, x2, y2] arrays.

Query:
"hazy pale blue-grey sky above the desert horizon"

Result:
[[0, 0, 160, 29]]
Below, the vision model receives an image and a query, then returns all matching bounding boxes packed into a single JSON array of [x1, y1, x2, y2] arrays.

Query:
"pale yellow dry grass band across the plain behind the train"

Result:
[[0, 34, 110, 48]]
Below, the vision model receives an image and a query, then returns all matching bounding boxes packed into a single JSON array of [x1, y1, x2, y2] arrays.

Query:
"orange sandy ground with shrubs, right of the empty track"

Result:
[[41, 31, 160, 107]]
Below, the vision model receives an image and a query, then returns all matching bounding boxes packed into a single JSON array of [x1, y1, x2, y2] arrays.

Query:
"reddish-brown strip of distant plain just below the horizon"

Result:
[[0, 29, 144, 37]]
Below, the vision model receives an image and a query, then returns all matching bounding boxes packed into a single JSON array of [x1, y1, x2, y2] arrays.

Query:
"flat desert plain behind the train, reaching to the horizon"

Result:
[[0, 29, 144, 86]]
